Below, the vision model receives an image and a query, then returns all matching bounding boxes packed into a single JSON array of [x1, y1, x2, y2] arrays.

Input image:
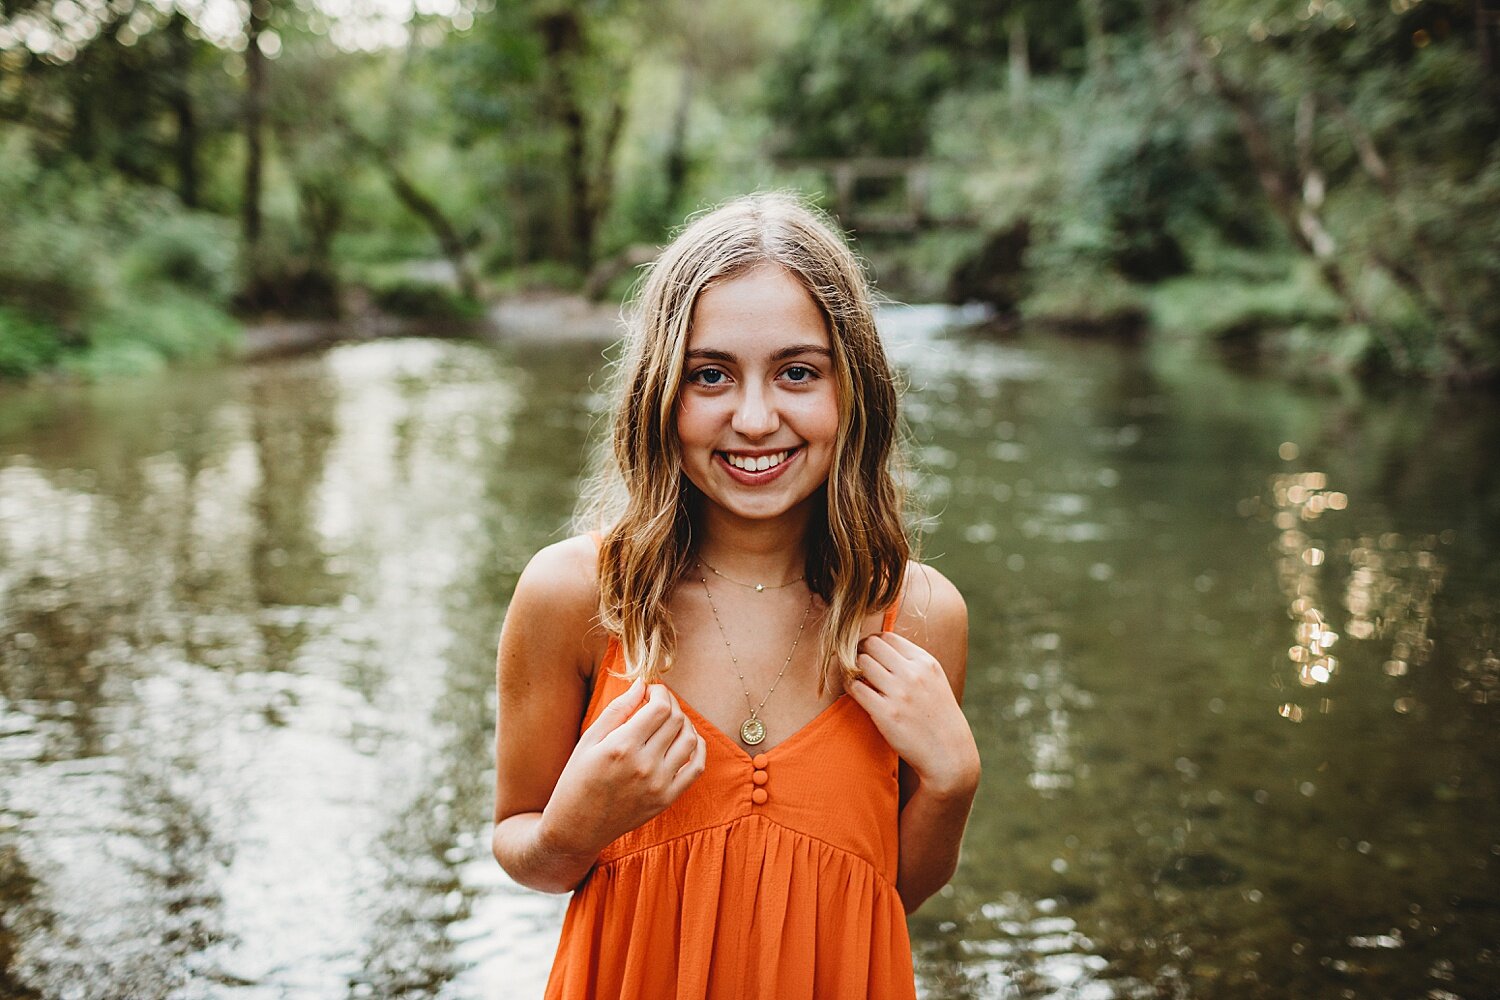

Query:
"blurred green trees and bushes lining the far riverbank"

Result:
[[0, 0, 1500, 375]]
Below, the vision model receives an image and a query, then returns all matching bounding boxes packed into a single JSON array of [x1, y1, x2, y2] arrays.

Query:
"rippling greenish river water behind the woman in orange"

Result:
[[0, 307, 1500, 1000]]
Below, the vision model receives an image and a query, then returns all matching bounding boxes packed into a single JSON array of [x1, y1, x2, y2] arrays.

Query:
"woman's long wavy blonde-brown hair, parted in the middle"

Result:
[[575, 193, 911, 693]]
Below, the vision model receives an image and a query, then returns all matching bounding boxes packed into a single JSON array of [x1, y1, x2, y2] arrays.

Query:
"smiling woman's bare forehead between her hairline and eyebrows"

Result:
[[687, 264, 831, 358]]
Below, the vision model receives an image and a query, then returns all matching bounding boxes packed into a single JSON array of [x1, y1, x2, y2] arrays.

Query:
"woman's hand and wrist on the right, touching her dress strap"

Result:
[[845, 633, 980, 795]]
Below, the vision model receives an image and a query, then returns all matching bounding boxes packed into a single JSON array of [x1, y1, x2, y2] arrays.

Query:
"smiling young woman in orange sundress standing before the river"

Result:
[[494, 195, 980, 1000]]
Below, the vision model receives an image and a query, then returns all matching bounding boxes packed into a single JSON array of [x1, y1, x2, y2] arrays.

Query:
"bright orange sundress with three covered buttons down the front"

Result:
[[545, 606, 917, 1000]]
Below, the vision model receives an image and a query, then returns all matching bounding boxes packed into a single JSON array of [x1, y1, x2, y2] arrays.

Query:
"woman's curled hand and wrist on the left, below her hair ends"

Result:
[[542, 679, 708, 856]]
